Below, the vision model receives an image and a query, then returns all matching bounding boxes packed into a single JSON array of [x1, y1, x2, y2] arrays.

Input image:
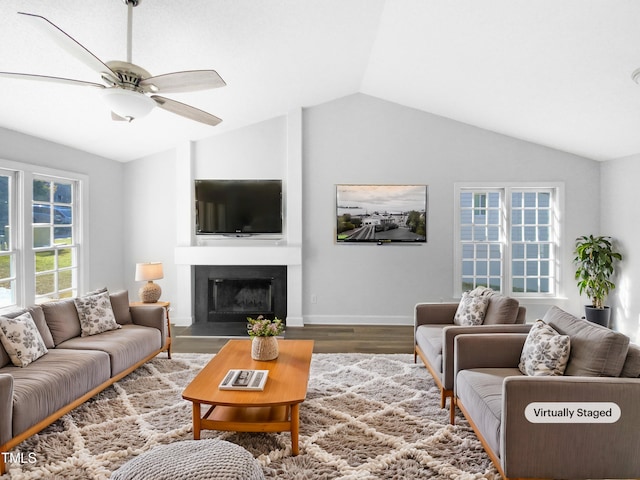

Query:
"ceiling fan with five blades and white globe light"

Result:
[[0, 0, 226, 126]]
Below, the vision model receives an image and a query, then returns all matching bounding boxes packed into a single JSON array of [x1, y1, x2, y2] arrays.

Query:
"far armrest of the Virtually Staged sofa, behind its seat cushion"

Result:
[[453, 333, 527, 378]]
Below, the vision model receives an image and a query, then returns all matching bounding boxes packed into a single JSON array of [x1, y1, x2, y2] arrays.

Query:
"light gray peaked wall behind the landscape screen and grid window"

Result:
[[303, 94, 600, 323]]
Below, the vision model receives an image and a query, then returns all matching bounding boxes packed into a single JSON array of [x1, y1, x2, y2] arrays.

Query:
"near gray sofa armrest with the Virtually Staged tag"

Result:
[[500, 376, 640, 478]]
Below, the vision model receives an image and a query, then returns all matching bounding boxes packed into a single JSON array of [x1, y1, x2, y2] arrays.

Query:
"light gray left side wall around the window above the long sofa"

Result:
[[0, 128, 127, 290]]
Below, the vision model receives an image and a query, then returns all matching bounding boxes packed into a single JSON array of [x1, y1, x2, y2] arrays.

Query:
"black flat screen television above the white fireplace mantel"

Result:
[[195, 179, 282, 236]]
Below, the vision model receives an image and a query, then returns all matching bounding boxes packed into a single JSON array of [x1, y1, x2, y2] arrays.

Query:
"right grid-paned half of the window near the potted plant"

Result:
[[511, 190, 555, 294]]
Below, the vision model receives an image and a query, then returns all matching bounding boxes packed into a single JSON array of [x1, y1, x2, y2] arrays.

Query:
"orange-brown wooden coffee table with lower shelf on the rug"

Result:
[[182, 339, 313, 455]]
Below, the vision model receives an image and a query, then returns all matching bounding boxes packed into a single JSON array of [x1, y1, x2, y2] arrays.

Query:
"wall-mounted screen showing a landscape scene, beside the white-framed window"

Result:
[[336, 185, 427, 244]]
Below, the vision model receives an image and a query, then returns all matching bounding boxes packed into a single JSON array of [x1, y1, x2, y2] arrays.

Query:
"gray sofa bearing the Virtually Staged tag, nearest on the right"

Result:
[[455, 307, 640, 479]]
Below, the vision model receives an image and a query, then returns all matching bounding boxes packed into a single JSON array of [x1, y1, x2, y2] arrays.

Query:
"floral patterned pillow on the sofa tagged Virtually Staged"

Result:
[[518, 320, 571, 376]]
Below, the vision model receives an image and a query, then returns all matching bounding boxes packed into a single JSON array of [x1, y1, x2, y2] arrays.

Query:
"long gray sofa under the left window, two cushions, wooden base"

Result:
[[0, 291, 167, 474]]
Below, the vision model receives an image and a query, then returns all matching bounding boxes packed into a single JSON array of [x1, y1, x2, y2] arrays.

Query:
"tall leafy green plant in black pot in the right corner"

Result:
[[573, 235, 622, 327]]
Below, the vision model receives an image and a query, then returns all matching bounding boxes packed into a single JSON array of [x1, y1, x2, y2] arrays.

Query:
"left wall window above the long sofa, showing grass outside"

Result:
[[0, 160, 88, 308]]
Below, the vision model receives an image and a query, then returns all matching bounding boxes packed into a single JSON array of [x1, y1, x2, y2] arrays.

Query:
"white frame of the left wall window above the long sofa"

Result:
[[0, 159, 90, 312]]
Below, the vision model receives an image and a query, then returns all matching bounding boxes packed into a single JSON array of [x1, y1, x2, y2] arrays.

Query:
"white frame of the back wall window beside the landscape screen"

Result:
[[453, 182, 564, 299]]
